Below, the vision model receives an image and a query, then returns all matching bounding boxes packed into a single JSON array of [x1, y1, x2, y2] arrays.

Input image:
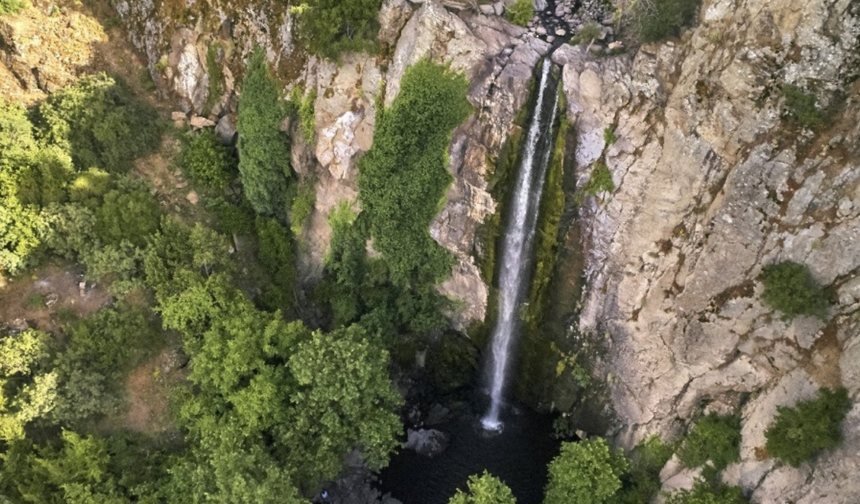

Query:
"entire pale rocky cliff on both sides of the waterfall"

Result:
[[107, 0, 860, 503]]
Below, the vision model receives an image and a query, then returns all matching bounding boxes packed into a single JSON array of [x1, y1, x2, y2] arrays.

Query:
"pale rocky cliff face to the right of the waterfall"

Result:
[[554, 0, 860, 503]]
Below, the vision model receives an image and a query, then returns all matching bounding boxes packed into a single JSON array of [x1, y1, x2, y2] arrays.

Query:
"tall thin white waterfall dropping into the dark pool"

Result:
[[481, 58, 558, 430]]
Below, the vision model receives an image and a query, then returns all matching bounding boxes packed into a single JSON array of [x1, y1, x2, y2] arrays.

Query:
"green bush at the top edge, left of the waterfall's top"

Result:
[[290, 0, 382, 59]]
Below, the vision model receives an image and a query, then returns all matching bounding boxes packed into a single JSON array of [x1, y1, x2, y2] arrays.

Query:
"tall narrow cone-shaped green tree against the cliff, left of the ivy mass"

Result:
[[236, 46, 291, 219]]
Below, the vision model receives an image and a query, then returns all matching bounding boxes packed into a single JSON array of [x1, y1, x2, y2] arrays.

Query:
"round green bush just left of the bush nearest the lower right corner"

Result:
[[678, 413, 741, 470]]
